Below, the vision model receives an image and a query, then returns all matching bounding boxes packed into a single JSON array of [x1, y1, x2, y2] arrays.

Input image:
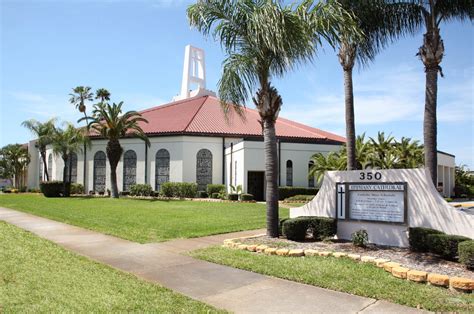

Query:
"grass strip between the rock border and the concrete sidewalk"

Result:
[[190, 247, 474, 312]]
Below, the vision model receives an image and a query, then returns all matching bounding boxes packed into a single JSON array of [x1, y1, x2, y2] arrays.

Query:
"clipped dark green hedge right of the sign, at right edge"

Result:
[[409, 227, 474, 266]]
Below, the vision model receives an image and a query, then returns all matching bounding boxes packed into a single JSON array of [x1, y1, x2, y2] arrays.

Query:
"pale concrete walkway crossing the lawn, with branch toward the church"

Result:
[[0, 207, 417, 313]]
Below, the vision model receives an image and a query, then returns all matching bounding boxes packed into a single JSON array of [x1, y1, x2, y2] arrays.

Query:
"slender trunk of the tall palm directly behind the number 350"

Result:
[[344, 67, 357, 170]]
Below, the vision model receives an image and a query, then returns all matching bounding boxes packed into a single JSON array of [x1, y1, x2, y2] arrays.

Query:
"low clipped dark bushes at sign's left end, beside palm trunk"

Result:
[[282, 216, 337, 241]]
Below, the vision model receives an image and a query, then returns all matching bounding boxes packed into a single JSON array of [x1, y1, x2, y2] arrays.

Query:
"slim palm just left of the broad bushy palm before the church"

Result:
[[51, 123, 88, 196]]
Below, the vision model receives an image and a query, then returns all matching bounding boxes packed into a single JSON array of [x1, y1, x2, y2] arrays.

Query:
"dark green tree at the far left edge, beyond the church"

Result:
[[0, 144, 30, 188]]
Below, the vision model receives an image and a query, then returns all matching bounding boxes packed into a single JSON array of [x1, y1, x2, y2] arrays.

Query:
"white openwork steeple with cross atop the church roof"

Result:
[[173, 45, 216, 101]]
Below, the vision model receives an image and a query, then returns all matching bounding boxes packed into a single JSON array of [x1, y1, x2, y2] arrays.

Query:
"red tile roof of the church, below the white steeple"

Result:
[[132, 96, 346, 143]]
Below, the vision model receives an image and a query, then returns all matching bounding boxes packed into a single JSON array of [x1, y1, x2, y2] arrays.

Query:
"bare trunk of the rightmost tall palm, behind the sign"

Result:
[[423, 68, 438, 187]]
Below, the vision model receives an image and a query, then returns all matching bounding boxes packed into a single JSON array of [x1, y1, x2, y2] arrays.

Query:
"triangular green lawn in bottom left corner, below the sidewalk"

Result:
[[0, 222, 223, 313]]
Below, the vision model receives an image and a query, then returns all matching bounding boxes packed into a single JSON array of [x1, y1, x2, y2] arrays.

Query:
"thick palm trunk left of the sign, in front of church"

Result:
[[263, 119, 279, 238]]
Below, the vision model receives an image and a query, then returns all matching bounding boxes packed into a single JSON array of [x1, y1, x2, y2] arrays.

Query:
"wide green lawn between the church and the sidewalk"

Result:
[[0, 194, 288, 243]]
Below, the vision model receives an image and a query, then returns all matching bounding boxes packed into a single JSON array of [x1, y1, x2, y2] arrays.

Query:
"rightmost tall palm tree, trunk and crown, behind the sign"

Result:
[[395, 0, 474, 186]]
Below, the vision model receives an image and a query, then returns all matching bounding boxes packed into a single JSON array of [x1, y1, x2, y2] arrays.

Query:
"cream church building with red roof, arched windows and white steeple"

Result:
[[28, 45, 456, 200]]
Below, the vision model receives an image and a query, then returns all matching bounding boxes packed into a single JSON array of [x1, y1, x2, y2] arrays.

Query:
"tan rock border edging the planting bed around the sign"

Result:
[[224, 234, 474, 293]]
